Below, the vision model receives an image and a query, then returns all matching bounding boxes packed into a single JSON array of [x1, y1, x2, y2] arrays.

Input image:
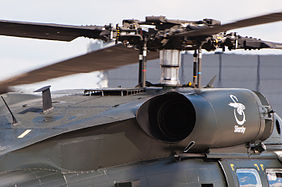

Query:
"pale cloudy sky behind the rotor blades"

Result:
[[0, 0, 282, 91]]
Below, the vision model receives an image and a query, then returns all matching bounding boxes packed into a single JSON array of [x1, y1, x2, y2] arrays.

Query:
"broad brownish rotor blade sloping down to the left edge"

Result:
[[0, 44, 158, 90]]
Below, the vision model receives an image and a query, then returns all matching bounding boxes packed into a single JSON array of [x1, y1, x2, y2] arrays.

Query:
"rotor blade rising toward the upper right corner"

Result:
[[174, 12, 282, 37]]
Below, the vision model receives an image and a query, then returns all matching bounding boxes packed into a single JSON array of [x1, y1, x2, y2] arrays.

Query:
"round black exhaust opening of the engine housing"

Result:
[[137, 92, 196, 142]]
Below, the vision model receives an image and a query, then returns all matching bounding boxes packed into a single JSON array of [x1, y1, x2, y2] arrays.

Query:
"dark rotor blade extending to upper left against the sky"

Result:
[[0, 20, 104, 41]]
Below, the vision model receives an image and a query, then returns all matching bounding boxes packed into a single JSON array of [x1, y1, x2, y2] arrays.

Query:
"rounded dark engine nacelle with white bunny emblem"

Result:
[[137, 89, 273, 149]]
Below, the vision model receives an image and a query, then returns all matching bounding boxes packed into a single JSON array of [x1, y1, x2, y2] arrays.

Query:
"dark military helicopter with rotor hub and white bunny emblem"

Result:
[[0, 12, 282, 187]]
